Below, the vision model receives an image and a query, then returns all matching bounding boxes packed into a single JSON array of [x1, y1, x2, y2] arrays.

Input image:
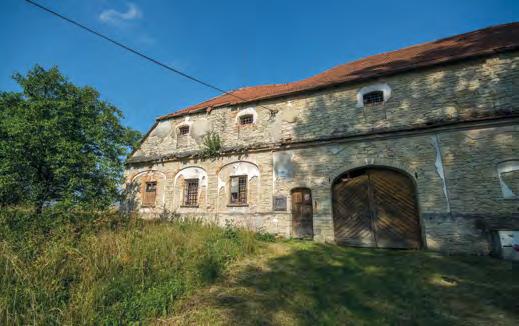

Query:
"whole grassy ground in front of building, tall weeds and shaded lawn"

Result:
[[0, 211, 519, 325]]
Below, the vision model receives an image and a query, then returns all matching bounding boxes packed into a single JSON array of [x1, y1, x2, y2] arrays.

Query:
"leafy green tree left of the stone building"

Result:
[[0, 66, 141, 212]]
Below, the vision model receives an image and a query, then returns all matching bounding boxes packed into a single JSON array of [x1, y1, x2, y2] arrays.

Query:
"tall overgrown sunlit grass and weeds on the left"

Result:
[[0, 209, 258, 325]]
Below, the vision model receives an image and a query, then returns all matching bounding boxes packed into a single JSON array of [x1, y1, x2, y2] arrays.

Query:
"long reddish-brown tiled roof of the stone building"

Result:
[[157, 22, 519, 120]]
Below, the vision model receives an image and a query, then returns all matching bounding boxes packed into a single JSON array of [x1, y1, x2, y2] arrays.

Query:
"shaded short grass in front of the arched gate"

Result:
[[201, 241, 519, 325]]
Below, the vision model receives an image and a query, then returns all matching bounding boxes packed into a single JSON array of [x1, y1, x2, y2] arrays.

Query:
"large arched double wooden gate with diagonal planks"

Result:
[[332, 167, 421, 249]]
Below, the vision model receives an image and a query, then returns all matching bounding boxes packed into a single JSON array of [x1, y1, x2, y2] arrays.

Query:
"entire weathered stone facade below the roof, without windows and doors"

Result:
[[126, 53, 519, 254]]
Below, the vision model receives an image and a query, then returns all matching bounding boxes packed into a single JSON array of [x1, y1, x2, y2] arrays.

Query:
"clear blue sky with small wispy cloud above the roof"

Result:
[[0, 0, 519, 131]]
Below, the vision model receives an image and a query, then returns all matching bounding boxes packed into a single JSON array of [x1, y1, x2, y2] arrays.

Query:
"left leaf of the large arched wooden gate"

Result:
[[333, 175, 376, 247]]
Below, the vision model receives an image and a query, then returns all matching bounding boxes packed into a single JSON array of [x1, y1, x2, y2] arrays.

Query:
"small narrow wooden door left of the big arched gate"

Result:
[[292, 188, 314, 239]]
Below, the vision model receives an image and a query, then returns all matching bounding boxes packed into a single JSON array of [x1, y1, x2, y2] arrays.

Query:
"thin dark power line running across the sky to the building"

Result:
[[25, 0, 277, 114]]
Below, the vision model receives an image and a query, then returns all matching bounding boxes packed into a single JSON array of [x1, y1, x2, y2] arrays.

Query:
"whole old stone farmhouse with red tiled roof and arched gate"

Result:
[[126, 23, 519, 254]]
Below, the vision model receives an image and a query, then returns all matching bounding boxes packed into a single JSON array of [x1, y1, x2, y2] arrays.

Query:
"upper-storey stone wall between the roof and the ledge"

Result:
[[133, 53, 519, 158]]
